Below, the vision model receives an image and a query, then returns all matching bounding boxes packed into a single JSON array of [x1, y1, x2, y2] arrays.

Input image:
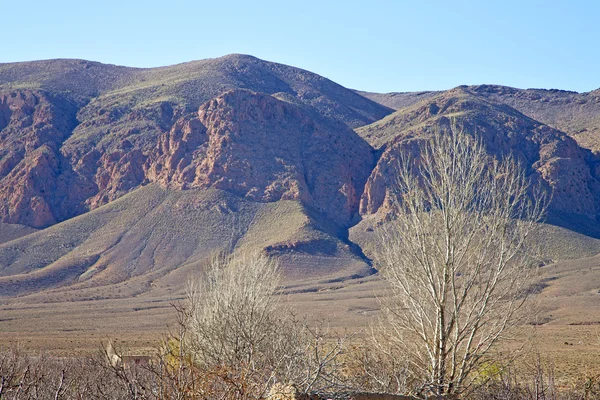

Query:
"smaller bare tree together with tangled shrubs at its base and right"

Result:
[[185, 253, 347, 399]]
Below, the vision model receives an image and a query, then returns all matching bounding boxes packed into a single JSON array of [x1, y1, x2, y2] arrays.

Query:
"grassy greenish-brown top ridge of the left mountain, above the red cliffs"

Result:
[[0, 54, 391, 127]]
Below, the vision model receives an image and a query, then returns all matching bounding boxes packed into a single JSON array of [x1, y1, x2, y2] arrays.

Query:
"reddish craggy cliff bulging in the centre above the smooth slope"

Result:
[[146, 90, 374, 225]]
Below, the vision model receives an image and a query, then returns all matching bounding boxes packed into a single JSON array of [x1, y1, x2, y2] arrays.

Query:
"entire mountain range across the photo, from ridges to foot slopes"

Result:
[[0, 55, 600, 302]]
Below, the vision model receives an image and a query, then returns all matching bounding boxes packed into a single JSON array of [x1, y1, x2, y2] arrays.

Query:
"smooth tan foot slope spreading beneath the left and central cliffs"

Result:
[[0, 185, 369, 301]]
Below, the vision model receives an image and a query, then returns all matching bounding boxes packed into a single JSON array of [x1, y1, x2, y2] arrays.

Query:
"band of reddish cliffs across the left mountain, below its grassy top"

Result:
[[0, 90, 374, 228]]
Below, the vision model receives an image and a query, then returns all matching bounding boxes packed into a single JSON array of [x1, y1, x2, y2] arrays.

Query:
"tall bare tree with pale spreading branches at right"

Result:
[[377, 128, 546, 396]]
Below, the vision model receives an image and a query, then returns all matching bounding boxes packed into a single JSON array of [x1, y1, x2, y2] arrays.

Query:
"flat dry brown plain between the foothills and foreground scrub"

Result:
[[0, 253, 600, 366]]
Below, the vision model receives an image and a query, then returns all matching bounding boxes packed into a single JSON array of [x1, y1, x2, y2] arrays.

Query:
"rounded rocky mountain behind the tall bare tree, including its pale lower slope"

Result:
[[350, 87, 600, 259]]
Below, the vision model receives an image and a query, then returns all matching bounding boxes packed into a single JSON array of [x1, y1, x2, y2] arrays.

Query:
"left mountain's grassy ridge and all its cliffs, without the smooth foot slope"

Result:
[[0, 55, 390, 228]]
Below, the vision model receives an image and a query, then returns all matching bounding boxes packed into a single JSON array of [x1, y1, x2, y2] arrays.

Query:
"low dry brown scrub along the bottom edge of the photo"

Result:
[[0, 342, 600, 400]]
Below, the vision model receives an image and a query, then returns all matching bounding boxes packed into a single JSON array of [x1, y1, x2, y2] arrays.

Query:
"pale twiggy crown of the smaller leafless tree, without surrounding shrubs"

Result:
[[187, 254, 279, 370]]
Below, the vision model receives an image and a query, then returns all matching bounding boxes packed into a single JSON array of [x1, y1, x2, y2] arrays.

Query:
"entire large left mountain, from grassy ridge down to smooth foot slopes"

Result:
[[0, 55, 384, 301]]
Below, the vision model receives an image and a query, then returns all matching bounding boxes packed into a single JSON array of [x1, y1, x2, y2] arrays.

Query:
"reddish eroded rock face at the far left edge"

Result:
[[0, 90, 83, 228]]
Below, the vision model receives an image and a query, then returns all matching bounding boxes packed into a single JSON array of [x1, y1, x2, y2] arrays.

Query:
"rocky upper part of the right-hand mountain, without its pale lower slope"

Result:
[[360, 89, 600, 219]]
